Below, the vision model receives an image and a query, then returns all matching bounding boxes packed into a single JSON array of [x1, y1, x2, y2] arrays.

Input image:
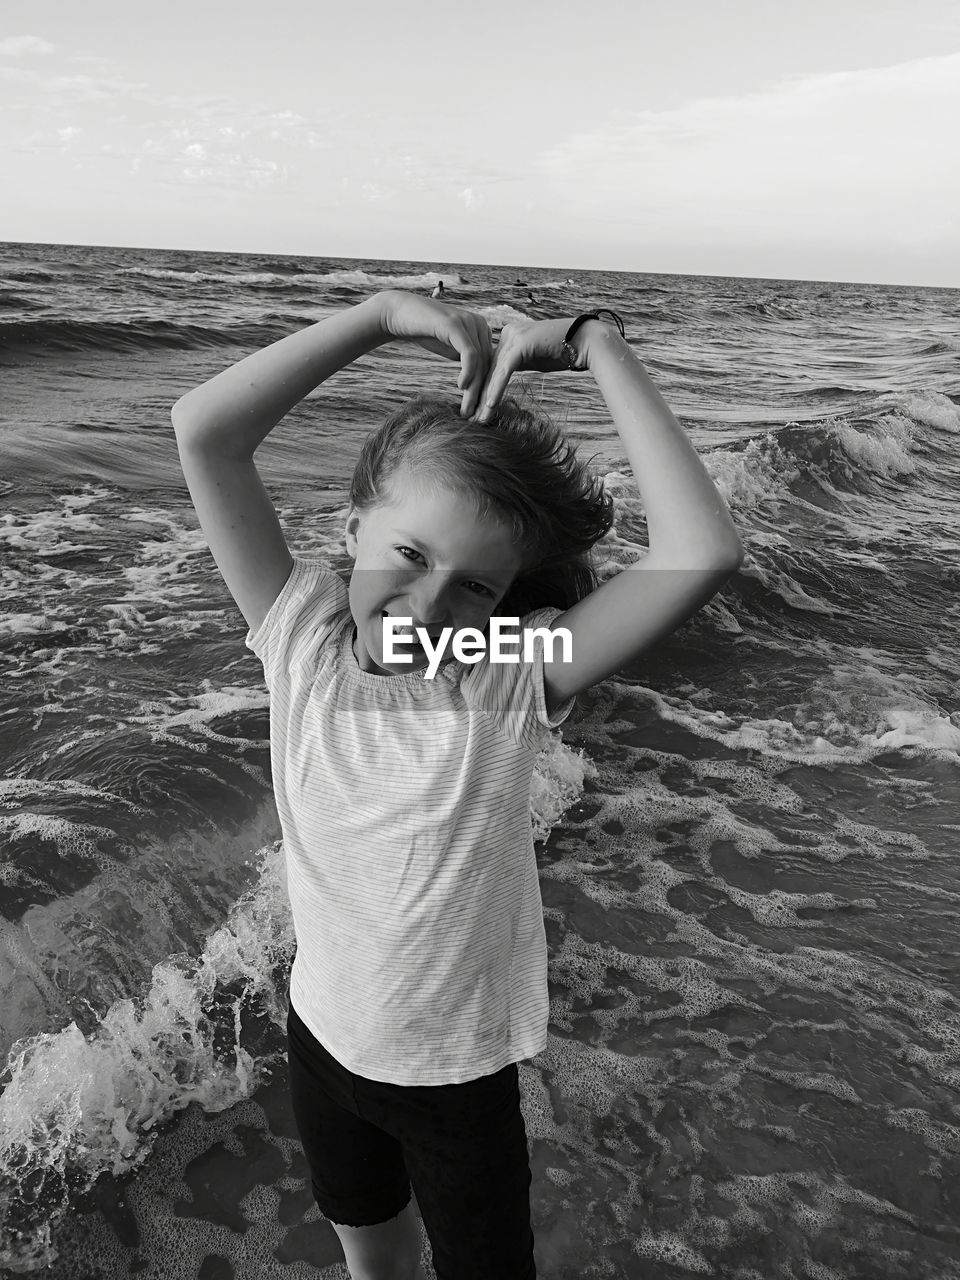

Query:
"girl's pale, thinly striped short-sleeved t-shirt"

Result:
[[246, 557, 575, 1084]]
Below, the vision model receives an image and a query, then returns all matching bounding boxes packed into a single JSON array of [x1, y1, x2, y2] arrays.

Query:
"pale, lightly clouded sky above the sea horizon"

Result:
[[0, 0, 960, 288]]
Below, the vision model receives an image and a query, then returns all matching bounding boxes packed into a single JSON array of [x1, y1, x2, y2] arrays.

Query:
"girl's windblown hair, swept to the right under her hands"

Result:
[[349, 396, 613, 617]]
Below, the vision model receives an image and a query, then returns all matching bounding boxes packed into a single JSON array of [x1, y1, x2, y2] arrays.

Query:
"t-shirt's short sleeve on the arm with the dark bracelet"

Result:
[[461, 607, 576, 749]]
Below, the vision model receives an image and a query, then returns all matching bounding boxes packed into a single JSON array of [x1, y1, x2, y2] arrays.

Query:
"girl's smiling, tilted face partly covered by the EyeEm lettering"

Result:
[[346, 471, 522, 676]]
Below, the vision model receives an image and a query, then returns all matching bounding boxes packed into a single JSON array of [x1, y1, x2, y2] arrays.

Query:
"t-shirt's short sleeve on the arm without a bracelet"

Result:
[[244, 556, 349, 689]]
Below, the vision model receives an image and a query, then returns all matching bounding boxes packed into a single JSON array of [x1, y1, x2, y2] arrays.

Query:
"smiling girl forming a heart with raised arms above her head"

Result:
[[173, 291, 742, 1280]]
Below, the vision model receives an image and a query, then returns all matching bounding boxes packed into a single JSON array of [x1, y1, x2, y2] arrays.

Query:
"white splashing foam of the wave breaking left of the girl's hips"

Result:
[[0, 844, 293, 1270]]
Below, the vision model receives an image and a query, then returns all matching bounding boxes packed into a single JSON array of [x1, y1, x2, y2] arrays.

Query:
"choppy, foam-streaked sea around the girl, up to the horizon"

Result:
[[0, 243, 960, 1280]]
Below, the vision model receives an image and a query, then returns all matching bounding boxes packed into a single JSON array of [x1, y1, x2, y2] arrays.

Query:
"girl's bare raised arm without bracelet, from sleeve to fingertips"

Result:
[[172, 291, 492, 631]]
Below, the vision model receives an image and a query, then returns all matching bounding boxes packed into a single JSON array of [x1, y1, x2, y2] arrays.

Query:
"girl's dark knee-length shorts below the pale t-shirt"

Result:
[[287, 1006, 536, 1280]]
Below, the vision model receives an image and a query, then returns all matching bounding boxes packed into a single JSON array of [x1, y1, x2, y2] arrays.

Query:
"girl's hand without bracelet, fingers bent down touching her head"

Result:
[[378, 289, 493, 417]]
